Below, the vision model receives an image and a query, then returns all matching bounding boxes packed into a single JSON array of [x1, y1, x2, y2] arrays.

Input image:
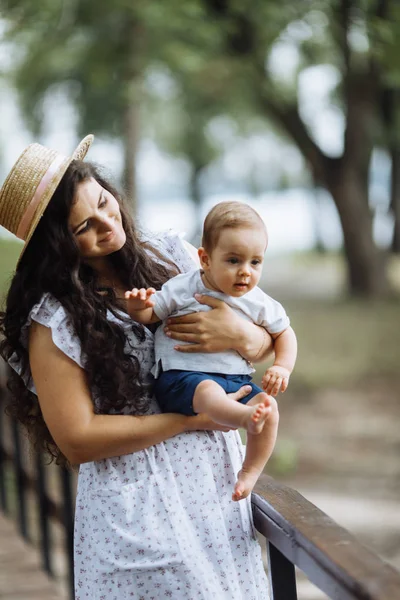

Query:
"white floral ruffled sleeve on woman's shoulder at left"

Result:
[[8, 293, 84, 394]]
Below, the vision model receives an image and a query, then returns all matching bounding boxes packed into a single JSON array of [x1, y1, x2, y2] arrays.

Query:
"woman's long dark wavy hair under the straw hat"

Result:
[[0, 160, 178, 464]]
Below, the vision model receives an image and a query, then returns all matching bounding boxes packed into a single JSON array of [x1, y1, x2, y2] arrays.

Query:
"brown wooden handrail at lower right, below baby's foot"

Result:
[[252, 475, 400, 600]]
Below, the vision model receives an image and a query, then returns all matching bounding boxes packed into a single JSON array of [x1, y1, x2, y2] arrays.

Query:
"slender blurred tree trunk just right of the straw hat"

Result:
[[123, 100, 139, 215]]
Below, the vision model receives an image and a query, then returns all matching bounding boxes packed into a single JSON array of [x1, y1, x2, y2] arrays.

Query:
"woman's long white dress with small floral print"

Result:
[[11, 234, 269, 600]]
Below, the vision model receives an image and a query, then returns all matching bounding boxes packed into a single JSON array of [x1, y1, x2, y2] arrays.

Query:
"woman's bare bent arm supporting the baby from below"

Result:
[[29, 323, 241, 464]]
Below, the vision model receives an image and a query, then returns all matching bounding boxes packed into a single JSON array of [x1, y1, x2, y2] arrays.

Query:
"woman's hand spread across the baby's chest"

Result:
[[165, 295, 273, 361]]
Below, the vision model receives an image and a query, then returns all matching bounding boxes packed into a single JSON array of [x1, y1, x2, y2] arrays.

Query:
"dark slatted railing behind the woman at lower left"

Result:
[[0, 359, 75, 600]]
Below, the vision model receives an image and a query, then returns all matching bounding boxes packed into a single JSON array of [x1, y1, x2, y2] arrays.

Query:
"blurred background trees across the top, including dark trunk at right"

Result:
[[1, 0, 400, 296]]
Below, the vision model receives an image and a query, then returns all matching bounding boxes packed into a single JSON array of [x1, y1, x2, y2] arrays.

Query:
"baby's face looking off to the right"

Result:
[[200, 227, 268, 298]]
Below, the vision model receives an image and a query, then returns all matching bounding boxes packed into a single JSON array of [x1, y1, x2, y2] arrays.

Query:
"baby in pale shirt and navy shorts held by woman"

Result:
[[125, 202, 297, 500]]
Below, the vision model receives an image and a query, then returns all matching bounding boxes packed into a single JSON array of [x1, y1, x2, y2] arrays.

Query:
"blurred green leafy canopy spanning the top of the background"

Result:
[[3, 0, 400, 155]]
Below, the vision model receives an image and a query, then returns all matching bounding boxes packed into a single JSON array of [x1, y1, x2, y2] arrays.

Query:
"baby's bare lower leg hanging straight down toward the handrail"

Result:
[[232, 396, 279, 500]]
